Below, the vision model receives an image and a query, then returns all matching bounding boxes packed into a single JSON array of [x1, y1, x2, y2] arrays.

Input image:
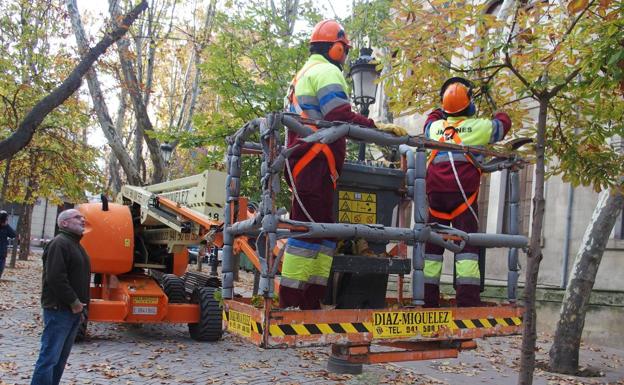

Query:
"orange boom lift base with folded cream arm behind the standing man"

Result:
[[78, 171, 226, 341]]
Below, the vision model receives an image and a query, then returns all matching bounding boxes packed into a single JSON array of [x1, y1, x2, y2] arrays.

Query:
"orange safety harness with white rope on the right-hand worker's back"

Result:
[[427, 120, 481, 223]]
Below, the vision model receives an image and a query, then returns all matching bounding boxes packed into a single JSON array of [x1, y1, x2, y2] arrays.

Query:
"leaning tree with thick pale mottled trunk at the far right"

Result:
[[549, 1, 624, 373]]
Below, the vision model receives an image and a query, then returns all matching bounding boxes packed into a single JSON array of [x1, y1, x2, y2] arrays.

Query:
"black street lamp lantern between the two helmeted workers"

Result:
[[349, 48, 379, 161]]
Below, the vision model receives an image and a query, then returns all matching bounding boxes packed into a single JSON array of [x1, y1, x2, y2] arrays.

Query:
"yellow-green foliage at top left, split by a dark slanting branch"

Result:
[[0, 1, 103, 203]]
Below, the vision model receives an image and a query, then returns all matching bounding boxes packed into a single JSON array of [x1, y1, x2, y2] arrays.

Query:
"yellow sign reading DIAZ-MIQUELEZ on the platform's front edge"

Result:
[[373, 310, 453, 338]]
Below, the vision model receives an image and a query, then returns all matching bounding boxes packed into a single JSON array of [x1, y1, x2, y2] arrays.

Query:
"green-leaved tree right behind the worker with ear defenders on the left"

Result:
[[191, 0, 320, 203]]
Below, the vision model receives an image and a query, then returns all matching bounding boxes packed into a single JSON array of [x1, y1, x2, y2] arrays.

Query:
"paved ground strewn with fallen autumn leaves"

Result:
[[0, 257, 624, 385]]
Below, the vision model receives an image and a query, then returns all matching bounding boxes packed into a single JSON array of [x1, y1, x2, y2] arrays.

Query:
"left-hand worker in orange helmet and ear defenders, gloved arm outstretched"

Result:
[[279, 20, 407, 309]]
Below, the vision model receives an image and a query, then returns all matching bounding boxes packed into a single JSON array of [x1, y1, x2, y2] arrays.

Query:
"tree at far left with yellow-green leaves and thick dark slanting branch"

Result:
[[0, 1, 124, 260]]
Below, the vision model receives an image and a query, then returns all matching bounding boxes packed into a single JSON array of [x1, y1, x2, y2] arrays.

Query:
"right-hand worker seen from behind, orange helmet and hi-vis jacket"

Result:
[[424, 77, 511, 307]]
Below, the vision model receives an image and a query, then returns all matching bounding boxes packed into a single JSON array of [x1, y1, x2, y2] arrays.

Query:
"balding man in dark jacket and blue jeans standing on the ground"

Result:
[[31, 209, 91, 385]]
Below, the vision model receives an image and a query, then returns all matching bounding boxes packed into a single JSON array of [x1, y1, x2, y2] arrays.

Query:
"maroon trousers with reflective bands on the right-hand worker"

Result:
[[424, 192, 481, 307]]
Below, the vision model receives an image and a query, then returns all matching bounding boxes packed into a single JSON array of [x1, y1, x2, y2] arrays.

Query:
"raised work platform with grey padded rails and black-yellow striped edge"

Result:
[[222, 113, 527, 373]]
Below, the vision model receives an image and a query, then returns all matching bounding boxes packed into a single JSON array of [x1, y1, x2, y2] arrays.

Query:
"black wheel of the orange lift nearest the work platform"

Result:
[[188, 287, 223, 341]]
